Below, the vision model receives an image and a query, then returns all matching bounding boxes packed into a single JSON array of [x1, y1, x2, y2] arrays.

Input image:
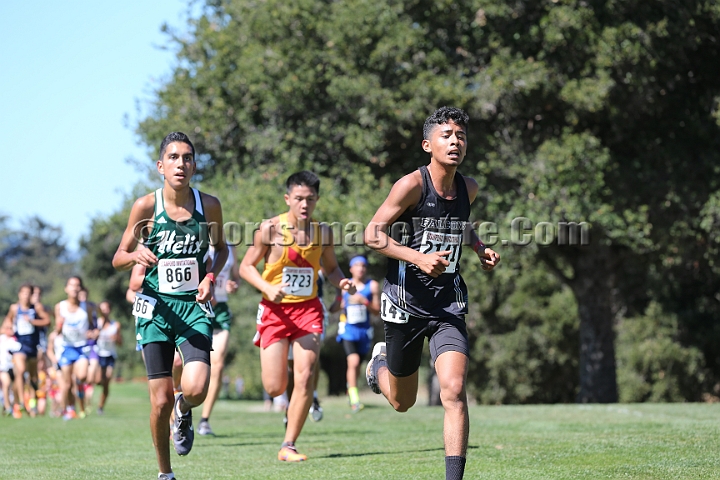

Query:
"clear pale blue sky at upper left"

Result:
[[0, 0, 194, 250]]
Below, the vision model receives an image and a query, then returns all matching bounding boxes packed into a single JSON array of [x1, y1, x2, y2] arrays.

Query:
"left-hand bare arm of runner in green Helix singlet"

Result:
[[113, 194, 157, 270]]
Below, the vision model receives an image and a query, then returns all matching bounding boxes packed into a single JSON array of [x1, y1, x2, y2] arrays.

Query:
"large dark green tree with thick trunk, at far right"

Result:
[[470, 1, 720, 401]]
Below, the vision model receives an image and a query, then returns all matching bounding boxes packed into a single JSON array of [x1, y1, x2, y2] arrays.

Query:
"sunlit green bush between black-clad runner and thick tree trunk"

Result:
[[467, 252, 579, 404]]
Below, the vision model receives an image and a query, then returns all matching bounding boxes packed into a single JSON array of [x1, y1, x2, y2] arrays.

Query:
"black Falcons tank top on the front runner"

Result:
[[383, 166, 470, 318]]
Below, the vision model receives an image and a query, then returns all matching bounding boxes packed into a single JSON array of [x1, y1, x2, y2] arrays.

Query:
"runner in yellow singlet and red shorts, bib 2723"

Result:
[[240, 171, 355, 462]]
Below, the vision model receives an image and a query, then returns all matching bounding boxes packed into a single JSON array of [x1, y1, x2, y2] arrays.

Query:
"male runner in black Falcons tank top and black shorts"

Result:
[[365, 107, 500, 480]]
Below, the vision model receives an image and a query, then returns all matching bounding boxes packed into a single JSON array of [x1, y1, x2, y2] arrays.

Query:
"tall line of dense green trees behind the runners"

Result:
[[2, 0, 720, 403]]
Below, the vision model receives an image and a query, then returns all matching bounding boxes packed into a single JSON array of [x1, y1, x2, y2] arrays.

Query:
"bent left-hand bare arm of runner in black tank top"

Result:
[[365, 172, 452, 277]]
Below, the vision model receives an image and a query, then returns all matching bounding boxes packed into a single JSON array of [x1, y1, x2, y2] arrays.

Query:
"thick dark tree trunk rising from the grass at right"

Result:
[[570, 245, 618, 403]]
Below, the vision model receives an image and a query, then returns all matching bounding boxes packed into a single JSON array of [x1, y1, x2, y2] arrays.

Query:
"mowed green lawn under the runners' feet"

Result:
[[0, 383, 720, 480]]
